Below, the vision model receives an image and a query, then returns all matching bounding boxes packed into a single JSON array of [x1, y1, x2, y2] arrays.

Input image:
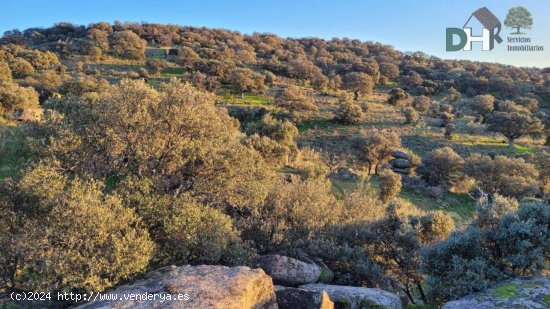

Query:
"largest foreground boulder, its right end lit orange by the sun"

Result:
[[78, 266, 277, 309]]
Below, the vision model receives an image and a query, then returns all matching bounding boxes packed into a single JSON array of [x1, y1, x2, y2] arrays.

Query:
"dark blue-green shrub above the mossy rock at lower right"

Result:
[[422, 203, 550, 301]]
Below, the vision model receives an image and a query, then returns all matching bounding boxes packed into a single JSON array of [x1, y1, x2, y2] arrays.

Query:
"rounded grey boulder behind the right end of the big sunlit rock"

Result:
[[255, 254, 321, 286]]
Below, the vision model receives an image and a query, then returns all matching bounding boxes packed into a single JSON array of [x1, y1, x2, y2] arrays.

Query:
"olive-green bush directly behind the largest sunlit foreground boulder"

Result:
[[117, 177, 251, 266]]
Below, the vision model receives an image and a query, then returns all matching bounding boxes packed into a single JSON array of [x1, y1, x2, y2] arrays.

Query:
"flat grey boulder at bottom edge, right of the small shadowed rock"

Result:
[[300, 283, 403, 309]]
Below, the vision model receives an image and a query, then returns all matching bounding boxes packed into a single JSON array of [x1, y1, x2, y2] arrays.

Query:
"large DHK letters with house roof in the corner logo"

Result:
[[446, 7, 502, 51]]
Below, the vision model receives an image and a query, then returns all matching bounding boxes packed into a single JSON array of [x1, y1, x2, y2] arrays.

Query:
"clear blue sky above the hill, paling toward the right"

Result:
[[0, 0, 550, 67]]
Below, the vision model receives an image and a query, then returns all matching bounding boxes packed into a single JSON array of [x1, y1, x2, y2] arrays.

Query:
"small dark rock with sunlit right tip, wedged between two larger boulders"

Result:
[[275, 286, 334, 309]]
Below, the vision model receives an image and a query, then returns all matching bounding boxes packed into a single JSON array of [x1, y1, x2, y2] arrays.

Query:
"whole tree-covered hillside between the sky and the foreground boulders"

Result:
[[0, 22, 550, 305]]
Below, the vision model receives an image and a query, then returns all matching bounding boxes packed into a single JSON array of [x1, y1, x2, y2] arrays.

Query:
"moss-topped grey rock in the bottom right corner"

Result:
[[442, 277, 550, 309]]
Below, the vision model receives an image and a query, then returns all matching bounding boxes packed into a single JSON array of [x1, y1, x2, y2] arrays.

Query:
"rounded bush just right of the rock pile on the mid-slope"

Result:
[[418, 147, 464, 187]]
